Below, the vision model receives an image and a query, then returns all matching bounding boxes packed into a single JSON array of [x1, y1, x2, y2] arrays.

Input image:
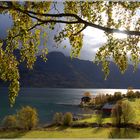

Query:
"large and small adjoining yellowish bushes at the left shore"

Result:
[[3, 106, 39, 130]]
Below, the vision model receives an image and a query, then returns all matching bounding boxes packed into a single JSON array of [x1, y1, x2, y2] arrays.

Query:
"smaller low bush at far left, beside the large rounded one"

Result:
[[3, 115, 17, 129]]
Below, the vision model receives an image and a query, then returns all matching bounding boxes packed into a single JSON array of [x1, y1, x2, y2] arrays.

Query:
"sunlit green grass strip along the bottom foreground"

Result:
[[0, 127, 140, 138]]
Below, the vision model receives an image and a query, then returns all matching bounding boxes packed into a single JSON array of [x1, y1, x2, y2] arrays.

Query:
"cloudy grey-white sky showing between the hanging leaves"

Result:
[[0, 12, 106, 61]]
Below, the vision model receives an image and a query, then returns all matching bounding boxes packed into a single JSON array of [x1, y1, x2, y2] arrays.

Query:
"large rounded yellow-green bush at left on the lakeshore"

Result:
[[17, 106, 38, 130]]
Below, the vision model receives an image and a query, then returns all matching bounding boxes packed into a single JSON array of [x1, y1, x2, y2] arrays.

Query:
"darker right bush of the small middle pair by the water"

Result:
[[63, 112, 73, 126]]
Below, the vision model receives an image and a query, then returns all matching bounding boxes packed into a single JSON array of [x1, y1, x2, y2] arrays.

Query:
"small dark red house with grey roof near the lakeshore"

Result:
[[102, 103, 115, 115]]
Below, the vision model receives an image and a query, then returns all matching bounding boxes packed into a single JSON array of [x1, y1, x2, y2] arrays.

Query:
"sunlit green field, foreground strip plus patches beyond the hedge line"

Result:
[[0, 99, 140, 138]]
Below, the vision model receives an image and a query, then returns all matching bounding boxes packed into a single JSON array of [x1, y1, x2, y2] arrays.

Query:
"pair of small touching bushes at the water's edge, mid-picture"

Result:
[[53, 112, 73, 126]]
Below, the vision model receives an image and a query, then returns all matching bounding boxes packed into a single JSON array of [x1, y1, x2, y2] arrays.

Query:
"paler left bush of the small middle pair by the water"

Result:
[[53, 112, 63, 125]]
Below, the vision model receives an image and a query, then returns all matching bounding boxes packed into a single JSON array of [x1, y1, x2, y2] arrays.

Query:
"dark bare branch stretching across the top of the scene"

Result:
[[0, 6, 140, 36]]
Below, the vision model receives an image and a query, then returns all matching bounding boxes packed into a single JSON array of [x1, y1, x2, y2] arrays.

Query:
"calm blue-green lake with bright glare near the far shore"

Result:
[[0, 88, 139, 123]]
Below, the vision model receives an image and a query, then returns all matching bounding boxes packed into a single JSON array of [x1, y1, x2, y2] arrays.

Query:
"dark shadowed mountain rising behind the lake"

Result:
[[0, 52, 140, 88]]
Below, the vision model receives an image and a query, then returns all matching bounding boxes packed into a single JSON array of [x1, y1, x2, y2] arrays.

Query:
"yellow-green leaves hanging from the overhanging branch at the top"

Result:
[[0, 1, 140, 105]]
